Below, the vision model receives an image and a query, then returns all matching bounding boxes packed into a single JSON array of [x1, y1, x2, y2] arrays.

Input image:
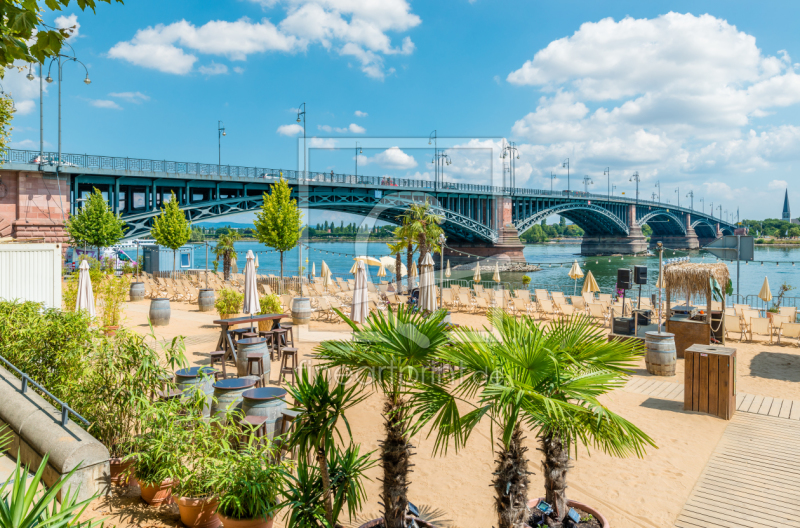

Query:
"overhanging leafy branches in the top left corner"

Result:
[[0, 0, 123, 71]]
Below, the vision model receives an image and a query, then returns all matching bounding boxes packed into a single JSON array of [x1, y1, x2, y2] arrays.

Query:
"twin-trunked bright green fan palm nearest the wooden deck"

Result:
[[412, 310, 655, 528]]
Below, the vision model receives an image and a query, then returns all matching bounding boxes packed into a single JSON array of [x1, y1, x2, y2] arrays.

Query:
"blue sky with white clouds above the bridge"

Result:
[[3, 0, 800, 222]]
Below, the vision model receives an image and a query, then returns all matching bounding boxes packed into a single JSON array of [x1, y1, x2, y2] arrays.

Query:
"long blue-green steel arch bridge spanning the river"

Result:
[[2, 149, 735, 248]]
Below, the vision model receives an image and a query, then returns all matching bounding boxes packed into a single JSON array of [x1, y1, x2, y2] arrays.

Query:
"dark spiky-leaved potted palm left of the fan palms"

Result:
[[284, 365, 374, 528]]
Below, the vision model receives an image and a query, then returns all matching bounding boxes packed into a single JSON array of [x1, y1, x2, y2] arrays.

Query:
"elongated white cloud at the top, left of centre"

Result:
[[109, 0, 421, 79]]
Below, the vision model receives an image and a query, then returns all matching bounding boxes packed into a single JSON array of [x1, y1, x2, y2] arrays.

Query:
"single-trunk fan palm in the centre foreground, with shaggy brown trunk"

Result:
[[316, 305, 448, 528]]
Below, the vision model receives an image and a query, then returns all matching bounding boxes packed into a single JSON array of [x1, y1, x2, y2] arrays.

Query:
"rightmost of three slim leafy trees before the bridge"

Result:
[[254, 178, 303, 281]]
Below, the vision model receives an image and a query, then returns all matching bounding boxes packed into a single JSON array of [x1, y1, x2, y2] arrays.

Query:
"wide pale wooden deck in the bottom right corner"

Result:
[[675, 412, 800, 528]]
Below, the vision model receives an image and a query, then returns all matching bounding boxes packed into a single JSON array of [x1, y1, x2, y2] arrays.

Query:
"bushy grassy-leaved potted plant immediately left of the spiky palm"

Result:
[[214, 435, 290, 528]]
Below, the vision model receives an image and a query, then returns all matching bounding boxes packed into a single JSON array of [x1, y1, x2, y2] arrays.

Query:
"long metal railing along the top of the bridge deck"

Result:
[[0, 149, 733, 226]]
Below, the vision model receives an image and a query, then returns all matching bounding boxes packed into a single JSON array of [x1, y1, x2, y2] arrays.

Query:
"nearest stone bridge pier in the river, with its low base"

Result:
[[444, 198, 525, 265]]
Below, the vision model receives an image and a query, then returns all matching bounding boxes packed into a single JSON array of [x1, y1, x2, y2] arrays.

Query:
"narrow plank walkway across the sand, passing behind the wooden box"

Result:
[[625, 376, 800, 418]]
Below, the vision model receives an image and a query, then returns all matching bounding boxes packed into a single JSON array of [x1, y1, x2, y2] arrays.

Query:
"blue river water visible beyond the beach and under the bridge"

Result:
[[195, 242, 800, 297]]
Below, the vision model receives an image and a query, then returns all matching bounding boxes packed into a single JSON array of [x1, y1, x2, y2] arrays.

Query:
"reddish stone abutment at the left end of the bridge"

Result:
[[0, 171, 70, 243]]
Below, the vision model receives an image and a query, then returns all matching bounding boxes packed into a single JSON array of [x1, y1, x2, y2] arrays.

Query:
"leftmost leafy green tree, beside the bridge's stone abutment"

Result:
[[64, 188, 125, 257]]
